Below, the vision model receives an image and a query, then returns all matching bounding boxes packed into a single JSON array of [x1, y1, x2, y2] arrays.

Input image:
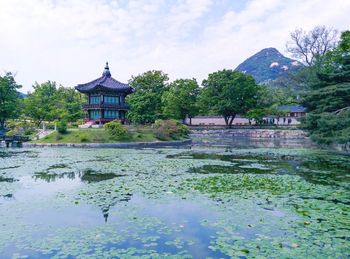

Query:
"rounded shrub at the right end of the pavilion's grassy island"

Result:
[[152, 120, 189, 140]]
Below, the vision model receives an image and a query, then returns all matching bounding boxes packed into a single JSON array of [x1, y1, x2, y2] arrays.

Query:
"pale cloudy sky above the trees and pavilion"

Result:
[[0, 0, 350, 92]]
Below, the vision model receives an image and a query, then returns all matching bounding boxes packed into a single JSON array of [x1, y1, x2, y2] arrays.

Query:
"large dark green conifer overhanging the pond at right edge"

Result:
[[302, 32, 350, 144]]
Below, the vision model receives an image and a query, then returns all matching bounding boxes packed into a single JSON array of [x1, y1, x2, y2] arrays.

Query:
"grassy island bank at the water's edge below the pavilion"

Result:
[[32, 129, 184, 144]]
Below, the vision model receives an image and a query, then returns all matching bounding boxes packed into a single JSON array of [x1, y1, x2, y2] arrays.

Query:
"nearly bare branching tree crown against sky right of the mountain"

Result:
[[286, 26, 338, 66]]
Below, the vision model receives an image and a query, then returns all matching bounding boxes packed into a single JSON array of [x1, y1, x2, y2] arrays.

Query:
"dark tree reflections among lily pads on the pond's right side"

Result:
[[166, 147, 350, 189]]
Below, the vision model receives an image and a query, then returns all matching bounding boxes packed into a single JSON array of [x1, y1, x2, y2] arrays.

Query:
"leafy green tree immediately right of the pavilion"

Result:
[[127, 70, 169, 124]]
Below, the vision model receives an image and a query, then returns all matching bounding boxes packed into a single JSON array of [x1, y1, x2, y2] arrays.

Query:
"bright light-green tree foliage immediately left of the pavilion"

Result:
[[24, 81, 83, 125]]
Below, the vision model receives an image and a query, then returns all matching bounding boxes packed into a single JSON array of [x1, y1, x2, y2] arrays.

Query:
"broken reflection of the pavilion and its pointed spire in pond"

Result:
[[33, 171, 132, 222]]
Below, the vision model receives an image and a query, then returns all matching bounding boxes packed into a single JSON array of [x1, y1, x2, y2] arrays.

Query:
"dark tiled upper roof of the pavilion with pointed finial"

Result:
[[75, 63, 134, 93]]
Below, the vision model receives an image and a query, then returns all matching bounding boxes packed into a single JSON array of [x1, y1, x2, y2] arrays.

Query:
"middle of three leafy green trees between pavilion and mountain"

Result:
[[162, 79, 200, 123]]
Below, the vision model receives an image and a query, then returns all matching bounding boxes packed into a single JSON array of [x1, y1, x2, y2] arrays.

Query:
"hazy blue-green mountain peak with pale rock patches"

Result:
[[235, 48, 303, 83]]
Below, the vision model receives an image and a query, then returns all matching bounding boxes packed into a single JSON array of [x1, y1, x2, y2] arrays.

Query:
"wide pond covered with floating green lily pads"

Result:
[[0, 142, 350, 258]]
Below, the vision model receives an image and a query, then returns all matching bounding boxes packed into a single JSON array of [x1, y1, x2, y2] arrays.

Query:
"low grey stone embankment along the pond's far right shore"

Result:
[[191, 129, 307, 139]]
